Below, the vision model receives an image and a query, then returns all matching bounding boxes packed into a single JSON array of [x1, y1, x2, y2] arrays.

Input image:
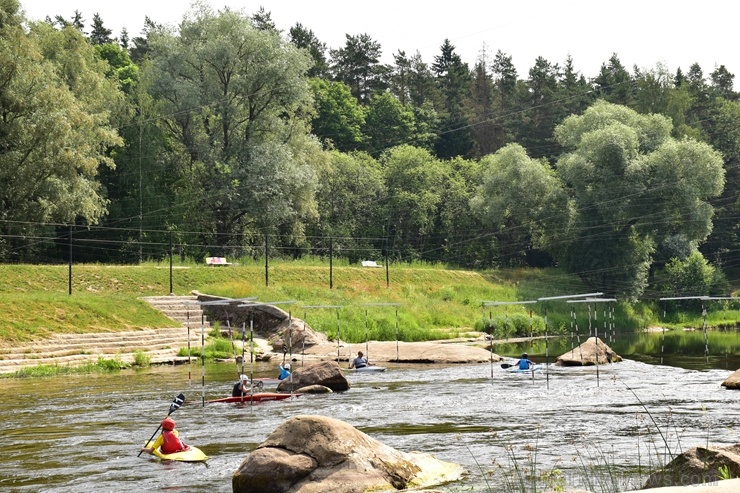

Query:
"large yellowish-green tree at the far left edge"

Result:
[[0, 8, 122, 258]]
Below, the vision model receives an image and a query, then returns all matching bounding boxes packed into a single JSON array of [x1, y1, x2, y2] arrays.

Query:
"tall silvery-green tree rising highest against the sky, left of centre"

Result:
[[147, 4, 320, 250]]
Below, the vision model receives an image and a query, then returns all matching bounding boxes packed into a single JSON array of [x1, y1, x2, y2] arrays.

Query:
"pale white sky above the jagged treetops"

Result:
[[20, 0, 740, 83]]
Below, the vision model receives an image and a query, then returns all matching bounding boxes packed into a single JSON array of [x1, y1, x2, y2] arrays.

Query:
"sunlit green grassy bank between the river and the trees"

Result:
[[0, 261, 737, 342]]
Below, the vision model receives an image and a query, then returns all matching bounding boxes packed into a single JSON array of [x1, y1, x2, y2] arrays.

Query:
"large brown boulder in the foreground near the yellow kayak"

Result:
[[231, 415, 463, 493]]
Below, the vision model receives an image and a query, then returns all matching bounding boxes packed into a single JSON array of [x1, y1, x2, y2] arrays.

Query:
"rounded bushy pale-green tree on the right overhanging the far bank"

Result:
[[556, 101, 724, 298]]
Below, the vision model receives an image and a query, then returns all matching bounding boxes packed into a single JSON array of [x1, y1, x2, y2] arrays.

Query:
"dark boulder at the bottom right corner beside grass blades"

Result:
[[644, 443, 740, 488]]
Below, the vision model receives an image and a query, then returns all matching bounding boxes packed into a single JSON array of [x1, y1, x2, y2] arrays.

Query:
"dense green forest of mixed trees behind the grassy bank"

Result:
[[0, 0, 740, 299]]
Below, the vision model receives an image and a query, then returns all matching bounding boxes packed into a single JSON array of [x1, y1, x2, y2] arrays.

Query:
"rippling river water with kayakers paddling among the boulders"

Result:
[[0, 330, 740, 493]]
